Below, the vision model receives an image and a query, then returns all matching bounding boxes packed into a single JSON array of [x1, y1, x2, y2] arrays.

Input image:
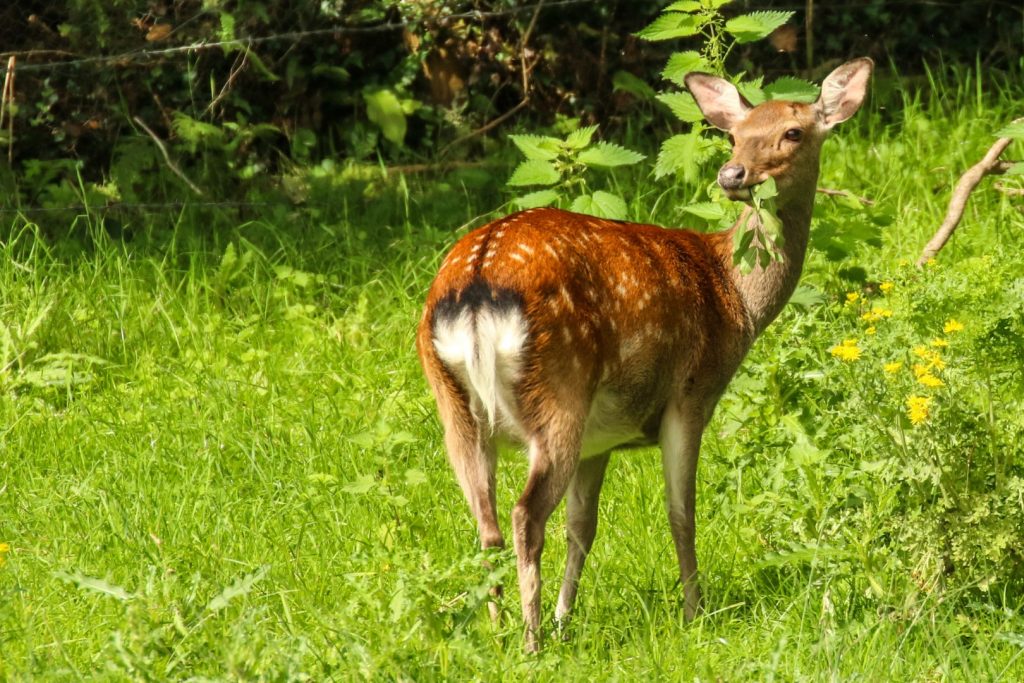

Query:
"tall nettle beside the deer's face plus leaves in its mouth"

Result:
[[637, 0, 818, 271]]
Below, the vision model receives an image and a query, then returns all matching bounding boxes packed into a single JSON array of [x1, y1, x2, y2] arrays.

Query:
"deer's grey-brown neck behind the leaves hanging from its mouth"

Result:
[[728, 186, 814, 336]]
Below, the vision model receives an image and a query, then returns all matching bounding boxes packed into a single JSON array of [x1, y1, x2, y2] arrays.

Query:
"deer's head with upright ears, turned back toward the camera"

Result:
[[686, 57, 874, 206]]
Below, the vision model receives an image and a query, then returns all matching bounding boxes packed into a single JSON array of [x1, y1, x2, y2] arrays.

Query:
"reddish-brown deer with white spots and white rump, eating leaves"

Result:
[[416, 57, 873, 651]]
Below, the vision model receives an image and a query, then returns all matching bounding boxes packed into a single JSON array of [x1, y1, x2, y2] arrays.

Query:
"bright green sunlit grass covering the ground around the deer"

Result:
[[0, 65, 1024, 681]]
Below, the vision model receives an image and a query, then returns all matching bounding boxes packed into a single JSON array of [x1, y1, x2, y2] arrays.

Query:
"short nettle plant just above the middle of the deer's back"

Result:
[[508, 126, 644, 220]]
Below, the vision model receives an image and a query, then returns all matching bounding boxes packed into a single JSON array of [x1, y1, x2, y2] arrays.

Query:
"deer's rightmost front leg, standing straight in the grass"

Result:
[[658, 405, 707, 622]]
